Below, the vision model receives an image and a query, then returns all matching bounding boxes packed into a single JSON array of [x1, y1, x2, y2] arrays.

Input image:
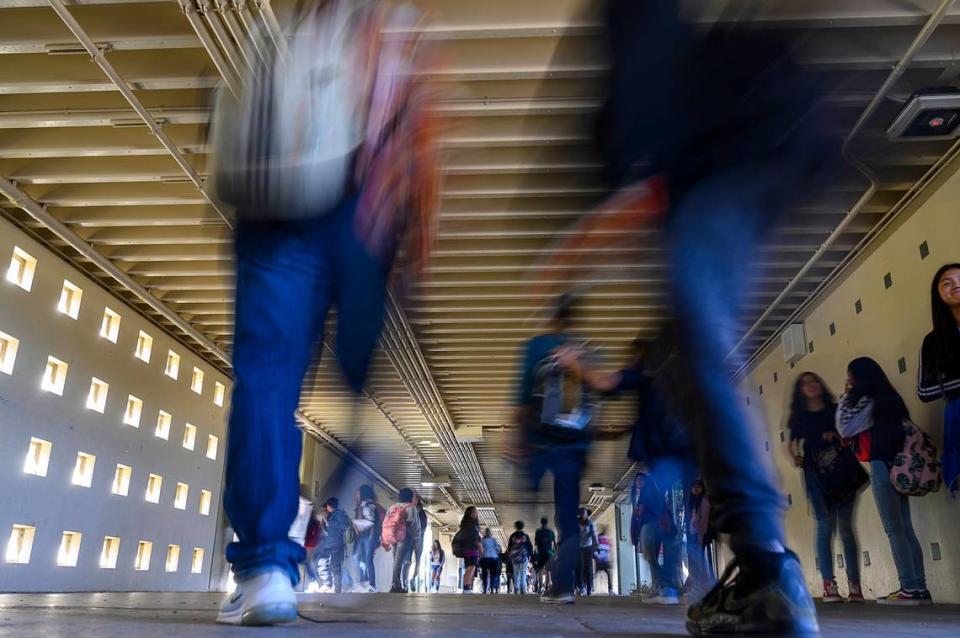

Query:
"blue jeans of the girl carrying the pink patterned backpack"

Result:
[[870, 461, 927, 590]]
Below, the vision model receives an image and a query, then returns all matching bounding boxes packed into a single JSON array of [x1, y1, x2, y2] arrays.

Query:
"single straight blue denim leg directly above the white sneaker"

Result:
[[224, 223, 330, 582]]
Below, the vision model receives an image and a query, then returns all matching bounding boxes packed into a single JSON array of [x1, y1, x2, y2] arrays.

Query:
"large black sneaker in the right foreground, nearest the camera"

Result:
[[687, 552, 820, 636]]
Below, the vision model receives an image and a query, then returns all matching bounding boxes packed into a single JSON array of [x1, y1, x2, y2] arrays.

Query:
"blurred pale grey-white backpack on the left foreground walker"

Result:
[[212, 0, 367, 220]]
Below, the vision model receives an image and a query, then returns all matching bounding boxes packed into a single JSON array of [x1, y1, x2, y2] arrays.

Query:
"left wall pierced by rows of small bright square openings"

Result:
[[0, 220, 230, 591]]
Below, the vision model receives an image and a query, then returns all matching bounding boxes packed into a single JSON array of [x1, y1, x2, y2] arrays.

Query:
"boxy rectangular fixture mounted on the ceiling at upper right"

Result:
[[887, 87, 960, 141]]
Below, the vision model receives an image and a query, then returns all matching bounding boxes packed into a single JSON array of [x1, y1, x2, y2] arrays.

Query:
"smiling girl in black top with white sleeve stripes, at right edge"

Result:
[[917, 263, 960, 495]]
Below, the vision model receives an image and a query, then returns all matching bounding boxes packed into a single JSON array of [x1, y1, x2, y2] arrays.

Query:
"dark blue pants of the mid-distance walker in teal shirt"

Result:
[[529, 447, 587, 592]]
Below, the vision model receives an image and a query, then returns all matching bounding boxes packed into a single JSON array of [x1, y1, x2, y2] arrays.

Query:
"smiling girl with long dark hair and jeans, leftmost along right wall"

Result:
[[788, 372, 863, 603]]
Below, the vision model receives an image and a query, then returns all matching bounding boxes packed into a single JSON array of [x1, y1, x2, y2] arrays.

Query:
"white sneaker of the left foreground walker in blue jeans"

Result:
[[217, 569, 297, 626]]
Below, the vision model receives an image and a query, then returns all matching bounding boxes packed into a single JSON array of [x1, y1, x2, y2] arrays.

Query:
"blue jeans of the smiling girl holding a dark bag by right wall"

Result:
[[803, 467, 860, 581]]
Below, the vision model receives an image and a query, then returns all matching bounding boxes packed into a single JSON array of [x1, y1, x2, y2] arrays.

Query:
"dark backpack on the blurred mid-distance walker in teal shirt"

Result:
[[533, 354, 594, 441]]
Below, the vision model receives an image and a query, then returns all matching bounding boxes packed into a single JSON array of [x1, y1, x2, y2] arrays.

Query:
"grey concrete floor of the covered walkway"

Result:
[[0, 593, 960, 638]]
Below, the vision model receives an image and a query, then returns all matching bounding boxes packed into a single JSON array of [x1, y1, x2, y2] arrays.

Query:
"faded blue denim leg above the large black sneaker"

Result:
[[667, 167, 786, 551]]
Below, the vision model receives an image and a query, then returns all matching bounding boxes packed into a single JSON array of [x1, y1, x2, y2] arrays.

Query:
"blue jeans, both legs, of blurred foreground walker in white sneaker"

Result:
[[224, 198, 388, 582]]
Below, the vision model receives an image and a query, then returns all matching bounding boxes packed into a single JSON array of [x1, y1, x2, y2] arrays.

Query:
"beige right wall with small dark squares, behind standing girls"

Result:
[[740, 162, 960, 603]]
